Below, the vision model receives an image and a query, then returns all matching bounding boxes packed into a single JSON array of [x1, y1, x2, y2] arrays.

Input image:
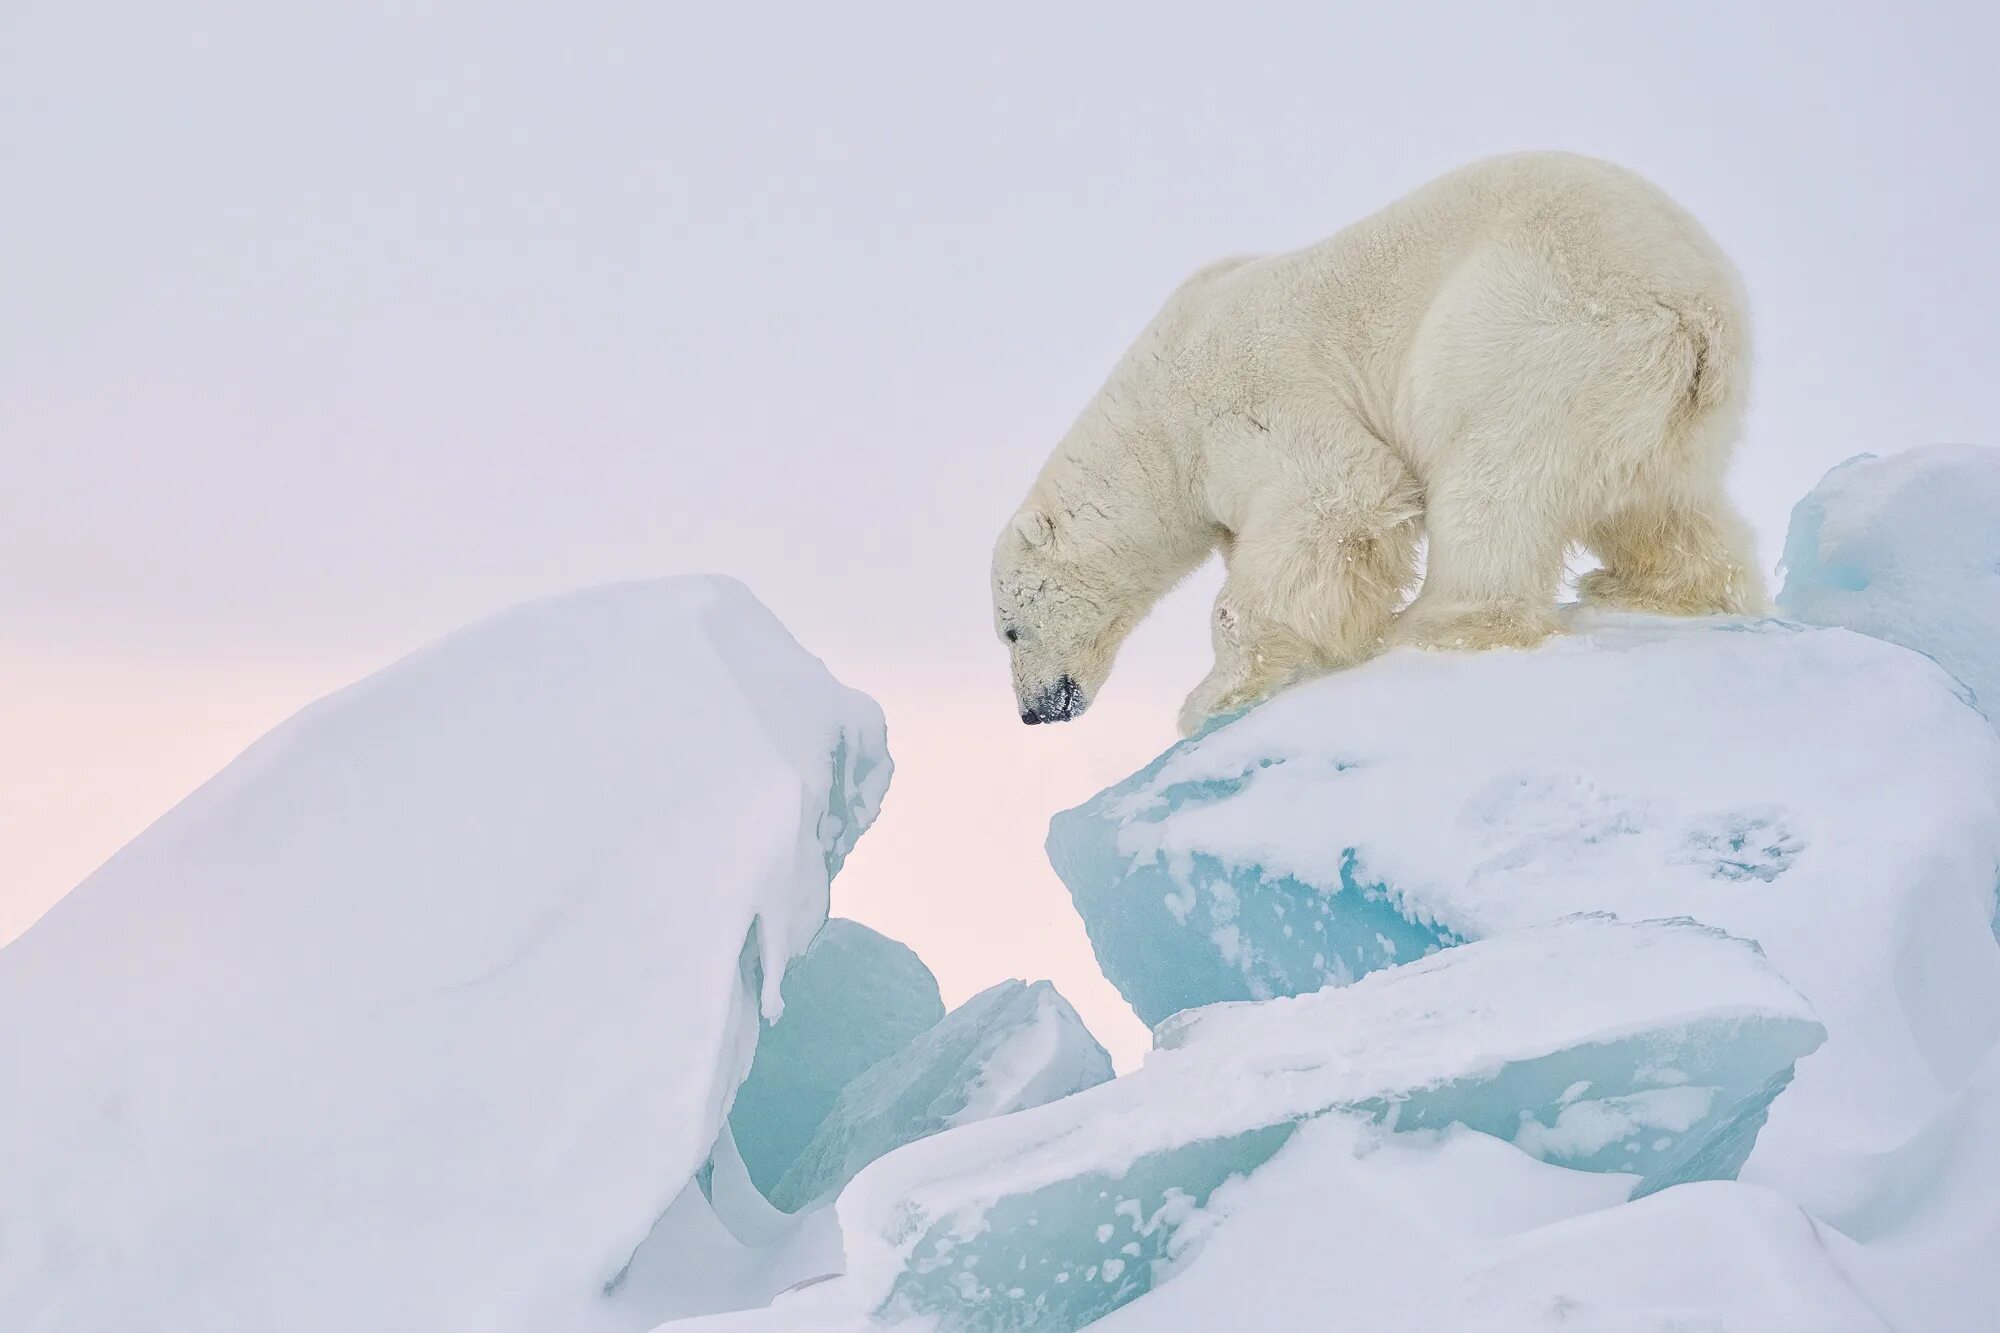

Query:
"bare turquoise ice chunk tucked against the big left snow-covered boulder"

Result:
[[730, 917, 944, 1197]]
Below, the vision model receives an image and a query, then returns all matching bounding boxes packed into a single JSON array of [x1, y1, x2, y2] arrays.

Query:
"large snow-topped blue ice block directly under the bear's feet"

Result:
[[1050, 614, 2000, 1203]]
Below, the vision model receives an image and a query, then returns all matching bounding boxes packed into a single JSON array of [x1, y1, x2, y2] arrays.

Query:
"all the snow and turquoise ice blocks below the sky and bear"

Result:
[[15, 488, 2000, 1333]]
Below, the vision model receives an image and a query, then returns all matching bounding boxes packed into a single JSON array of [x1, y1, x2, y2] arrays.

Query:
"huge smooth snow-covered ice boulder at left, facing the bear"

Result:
[[0, 578, 890, 1333]]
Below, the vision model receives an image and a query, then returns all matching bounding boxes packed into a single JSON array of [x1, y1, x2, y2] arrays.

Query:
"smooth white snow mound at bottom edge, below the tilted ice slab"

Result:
[[1092, 1117, 1880, 1333]]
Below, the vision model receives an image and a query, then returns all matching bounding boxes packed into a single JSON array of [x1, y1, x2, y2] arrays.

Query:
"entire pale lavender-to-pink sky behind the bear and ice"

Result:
[[0, 0, 2000, 1059]]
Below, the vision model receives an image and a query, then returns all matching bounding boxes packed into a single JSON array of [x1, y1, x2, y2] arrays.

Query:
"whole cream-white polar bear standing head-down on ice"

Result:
[[992, 152, 1766, 733]]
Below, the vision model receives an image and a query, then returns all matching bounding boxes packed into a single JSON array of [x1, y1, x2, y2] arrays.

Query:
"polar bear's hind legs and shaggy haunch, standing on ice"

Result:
[[1398, 235, 1762, 648]]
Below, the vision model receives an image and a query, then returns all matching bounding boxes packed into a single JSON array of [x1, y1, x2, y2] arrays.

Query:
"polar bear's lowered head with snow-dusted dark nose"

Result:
[[994, 508, 1144, 725]]
